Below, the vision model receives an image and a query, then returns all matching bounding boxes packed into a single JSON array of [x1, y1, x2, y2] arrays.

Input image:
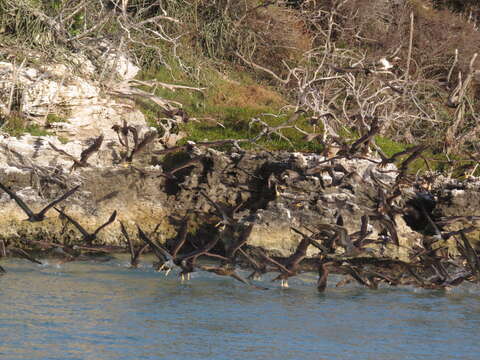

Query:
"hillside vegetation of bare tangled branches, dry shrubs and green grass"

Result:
[[0, 0, 480, 169]]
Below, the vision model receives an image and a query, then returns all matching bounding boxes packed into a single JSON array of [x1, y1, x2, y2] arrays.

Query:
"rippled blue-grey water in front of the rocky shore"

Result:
[[0, 259, 480, 360]]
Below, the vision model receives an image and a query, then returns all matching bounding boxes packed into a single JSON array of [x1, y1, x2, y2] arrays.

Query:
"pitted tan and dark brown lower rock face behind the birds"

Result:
[[0, 138, 478, 260]]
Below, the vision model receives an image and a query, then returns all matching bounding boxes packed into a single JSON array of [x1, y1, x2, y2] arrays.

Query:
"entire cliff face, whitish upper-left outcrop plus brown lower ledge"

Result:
[[0, 52, 480, 260]]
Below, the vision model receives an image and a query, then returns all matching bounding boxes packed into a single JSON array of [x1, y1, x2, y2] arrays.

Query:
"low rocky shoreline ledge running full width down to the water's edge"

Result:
[[0, 135, 480, 287]]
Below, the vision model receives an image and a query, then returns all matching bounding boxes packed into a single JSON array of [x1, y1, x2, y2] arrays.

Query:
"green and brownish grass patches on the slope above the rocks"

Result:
[[138, 60, 462, 173]]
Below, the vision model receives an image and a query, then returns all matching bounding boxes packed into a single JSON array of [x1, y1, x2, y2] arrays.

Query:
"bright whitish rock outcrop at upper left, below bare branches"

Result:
[[0, 52, 146, 141]]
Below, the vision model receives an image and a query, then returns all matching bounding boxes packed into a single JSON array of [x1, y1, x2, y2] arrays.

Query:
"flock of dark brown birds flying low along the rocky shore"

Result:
[[0, 115, 480, 292]]
